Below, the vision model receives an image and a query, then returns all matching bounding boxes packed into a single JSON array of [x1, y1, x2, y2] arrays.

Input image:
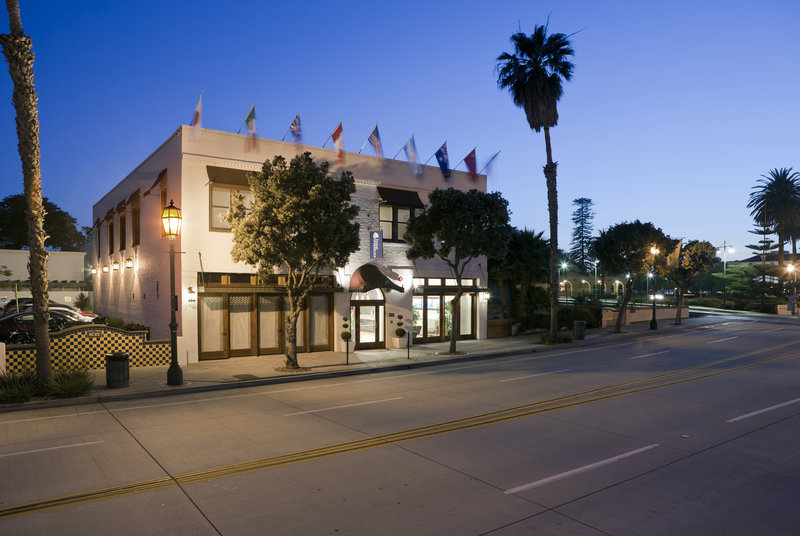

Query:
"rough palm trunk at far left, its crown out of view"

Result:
[[0, 0, 51, 384]]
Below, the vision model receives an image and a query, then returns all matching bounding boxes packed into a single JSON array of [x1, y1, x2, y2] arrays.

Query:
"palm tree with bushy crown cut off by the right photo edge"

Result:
[[747, 168, 800, 272]]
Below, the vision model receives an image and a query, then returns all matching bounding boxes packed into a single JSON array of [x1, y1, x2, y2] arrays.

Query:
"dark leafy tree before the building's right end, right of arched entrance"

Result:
[[403, 188, 511, 354]]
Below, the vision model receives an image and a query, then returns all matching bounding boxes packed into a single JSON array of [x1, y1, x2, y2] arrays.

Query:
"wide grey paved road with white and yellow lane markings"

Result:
[[0, 319, 800, 536]]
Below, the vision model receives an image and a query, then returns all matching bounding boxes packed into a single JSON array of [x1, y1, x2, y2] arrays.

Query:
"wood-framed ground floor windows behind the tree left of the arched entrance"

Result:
[[197, 292, 333, 359]]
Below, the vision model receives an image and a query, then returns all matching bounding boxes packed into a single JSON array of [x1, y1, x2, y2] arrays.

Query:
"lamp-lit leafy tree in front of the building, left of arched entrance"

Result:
[[226, 152, 359, 368]]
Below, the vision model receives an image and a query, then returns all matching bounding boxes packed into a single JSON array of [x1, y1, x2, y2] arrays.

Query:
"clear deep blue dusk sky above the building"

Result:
[[0, 0, 800, 260]]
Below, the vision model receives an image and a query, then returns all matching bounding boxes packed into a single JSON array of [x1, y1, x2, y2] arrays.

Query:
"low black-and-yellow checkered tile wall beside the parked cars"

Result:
[[6, 326, 170, 372]]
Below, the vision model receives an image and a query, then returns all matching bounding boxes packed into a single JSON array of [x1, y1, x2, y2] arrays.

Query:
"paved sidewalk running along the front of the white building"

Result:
[[0, 317, 732, 412]]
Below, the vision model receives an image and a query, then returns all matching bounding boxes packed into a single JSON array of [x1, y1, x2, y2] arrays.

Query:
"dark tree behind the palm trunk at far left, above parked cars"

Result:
[[0, 194, 86, 251]]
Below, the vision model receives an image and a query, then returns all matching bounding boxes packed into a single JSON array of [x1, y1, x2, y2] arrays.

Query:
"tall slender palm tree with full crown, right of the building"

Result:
[[496, 26, 574, 340]]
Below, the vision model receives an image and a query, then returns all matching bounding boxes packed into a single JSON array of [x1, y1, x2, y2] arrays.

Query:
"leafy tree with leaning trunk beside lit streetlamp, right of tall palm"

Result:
[[589, 220, 678, 333]]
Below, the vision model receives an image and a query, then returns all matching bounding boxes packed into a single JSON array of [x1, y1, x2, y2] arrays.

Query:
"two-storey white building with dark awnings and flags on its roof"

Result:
[[91, 126, 487, 363]]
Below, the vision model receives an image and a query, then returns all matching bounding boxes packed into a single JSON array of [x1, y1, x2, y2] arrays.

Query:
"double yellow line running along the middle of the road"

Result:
[[0, 342, 800, 519]]
